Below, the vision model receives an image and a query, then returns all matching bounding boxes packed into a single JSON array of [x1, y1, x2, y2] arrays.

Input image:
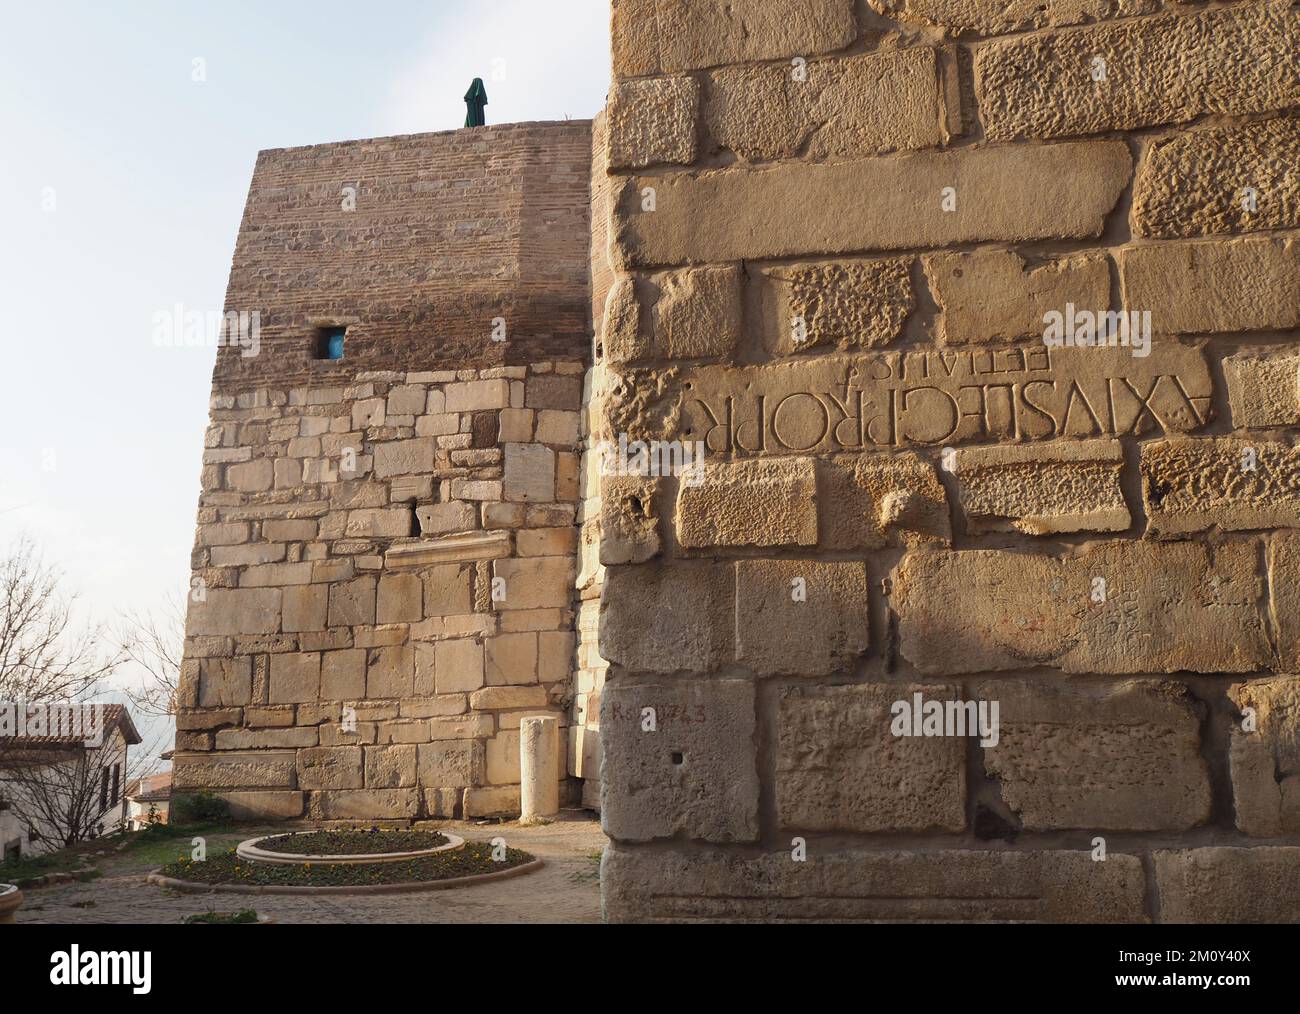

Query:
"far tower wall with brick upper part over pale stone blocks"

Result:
[[174, 122, 592, 820]]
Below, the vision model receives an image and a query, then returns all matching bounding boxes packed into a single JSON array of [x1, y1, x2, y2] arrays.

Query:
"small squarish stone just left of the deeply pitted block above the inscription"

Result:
[[651, 268, 742, 359]]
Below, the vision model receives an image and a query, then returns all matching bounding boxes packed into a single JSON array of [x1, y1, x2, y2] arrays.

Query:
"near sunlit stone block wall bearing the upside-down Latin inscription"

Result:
[[593, 0, 1300, 922]]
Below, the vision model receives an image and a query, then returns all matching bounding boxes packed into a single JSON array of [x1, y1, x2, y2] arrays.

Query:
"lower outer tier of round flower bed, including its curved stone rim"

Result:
[[150, 842, 542, 893]]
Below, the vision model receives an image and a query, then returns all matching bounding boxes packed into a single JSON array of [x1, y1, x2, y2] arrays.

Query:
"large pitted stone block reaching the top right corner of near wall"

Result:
[[975, 0, 1300, 140]]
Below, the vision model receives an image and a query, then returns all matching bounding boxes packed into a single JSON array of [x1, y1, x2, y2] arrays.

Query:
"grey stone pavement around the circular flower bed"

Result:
[[18, 811, 606, 924]]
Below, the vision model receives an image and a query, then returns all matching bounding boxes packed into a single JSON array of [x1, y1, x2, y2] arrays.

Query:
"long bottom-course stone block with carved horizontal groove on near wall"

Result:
[[601, 845, 1147, 923]]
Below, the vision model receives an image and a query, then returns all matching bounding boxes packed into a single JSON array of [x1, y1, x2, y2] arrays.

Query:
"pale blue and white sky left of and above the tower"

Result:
[[0, 0, 610, 754]]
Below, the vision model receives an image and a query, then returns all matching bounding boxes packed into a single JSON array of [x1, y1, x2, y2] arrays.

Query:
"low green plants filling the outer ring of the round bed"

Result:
[[159, 842, 533, 887]]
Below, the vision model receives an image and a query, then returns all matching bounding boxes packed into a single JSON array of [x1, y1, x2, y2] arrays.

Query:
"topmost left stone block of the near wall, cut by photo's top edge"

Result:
[[612, 0, 857, 77]]
